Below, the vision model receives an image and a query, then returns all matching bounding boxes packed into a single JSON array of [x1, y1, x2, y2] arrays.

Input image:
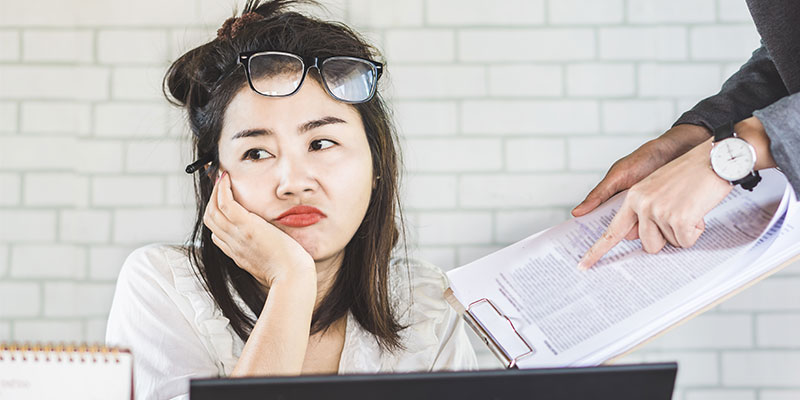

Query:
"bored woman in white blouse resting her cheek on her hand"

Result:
[[106, 0, 476, 398]]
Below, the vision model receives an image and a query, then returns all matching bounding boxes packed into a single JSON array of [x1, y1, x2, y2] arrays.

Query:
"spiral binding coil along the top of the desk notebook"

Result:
[[0, 342, 121, 363]]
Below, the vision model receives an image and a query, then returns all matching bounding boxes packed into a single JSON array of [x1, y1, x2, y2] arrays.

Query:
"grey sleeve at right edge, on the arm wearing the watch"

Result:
[[753, 93, 800, 197]]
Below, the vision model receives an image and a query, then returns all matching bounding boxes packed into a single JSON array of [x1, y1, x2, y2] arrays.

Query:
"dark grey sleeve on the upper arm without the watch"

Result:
[[673, 46, 789, 130]]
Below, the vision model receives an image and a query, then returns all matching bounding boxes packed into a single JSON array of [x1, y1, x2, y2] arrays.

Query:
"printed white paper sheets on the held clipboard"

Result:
[[448, 170, 800, 368]]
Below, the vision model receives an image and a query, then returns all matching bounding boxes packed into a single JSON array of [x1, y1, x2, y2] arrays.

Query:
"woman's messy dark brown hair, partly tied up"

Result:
[[164, 0, 406, 350]]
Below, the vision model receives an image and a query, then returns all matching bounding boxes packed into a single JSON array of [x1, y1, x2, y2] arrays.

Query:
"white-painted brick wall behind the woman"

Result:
[[0, 0, 800, 400]]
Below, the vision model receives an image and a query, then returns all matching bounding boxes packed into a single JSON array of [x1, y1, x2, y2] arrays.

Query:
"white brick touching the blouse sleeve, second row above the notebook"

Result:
[[44, 282, 114, 317]]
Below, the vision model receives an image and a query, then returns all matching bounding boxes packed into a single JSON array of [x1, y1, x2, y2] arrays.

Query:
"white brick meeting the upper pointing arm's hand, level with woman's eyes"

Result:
[[568, 137, 646, 171]]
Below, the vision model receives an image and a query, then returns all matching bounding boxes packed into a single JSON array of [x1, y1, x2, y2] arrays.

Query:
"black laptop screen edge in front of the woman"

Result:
[[189, 363, 678, 400]]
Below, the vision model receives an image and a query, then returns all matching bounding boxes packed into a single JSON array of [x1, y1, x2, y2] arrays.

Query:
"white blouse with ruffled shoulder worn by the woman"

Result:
[[106, 245, 477, 399]]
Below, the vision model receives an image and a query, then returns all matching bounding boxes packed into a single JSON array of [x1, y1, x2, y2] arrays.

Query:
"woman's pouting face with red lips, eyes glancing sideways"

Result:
[[219, 77, 373, 261]]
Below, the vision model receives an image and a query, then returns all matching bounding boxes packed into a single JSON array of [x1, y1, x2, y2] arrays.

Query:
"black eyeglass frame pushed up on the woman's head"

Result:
[[238, 51, 383, 104]]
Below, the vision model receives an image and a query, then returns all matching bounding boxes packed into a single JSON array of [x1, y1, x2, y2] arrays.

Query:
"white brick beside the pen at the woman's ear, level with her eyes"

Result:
[[125, 139, 193, 173]]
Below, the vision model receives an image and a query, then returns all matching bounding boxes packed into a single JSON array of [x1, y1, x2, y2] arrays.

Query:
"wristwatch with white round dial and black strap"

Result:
[[711, 122, 761, 192]]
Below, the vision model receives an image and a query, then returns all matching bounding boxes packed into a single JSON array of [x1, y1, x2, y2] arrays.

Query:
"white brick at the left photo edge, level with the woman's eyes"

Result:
[[0, 136, 75, 171]]
